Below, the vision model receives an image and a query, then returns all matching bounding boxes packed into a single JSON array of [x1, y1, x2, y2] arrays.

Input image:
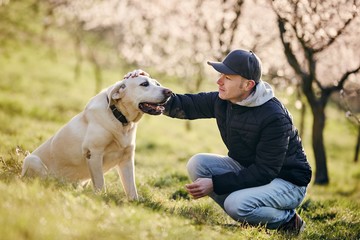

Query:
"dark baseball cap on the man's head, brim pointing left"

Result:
[[207, 49, 261, 83]]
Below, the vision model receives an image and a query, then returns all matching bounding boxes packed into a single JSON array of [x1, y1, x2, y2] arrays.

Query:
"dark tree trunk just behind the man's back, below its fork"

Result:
[[311, 104, 329, 185]]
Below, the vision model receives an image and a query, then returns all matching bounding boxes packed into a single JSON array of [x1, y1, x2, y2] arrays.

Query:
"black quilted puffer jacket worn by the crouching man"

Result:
[[164, 92, 311, 194]]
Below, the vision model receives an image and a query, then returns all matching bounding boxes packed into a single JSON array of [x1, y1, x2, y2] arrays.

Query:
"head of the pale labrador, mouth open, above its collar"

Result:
[[108, 75, 172, 115]]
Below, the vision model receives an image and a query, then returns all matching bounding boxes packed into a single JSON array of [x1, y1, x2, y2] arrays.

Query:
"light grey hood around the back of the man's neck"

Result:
[[236, 80, 275, 107]]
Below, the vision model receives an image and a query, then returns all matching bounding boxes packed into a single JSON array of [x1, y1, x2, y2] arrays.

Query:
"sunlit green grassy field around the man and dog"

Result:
[[0, 6, 360, 240]]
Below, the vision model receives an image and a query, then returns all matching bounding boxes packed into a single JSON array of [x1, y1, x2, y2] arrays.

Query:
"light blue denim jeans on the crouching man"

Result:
[[187, 153, 306, 229]]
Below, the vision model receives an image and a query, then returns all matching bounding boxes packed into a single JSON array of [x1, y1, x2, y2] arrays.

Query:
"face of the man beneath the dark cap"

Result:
[[216, 74, 255, 103]]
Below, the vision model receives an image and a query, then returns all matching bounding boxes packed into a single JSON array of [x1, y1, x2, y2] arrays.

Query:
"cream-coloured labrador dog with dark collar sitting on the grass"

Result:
[[21, 71, 172, 200]]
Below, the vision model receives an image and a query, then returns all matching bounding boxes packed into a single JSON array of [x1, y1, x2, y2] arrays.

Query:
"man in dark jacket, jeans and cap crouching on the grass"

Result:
[[128, 50, 311, 234]]
